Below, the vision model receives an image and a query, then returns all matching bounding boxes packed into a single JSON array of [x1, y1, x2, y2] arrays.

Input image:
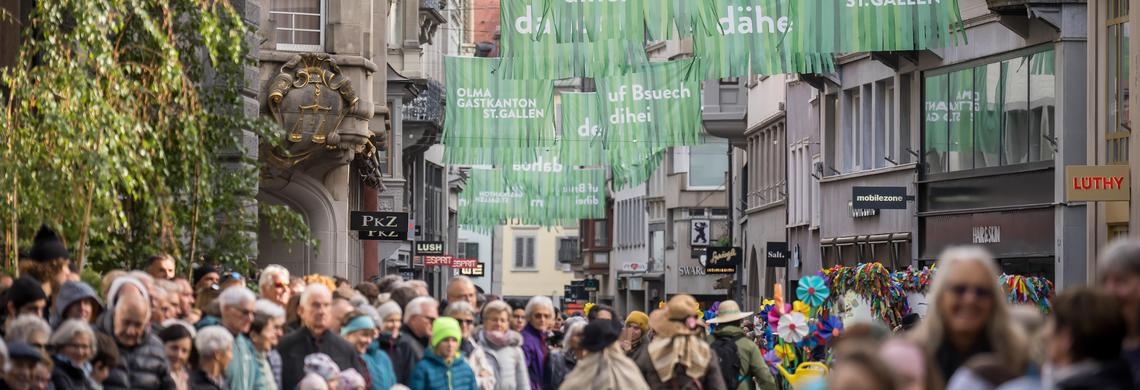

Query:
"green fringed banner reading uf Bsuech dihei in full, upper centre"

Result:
[[597, 59, 705, 188]]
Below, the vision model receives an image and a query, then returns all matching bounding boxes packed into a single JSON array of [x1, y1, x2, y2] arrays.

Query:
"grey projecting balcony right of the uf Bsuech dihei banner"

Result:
[[701, 78, 748, 145]]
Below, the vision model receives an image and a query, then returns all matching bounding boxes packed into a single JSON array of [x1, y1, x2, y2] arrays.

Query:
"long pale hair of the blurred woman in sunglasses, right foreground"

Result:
[[911, 245, 1028, 373]]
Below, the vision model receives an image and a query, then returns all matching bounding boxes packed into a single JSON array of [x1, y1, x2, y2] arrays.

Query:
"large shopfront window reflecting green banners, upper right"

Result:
[[922, 50, 1057, 173]]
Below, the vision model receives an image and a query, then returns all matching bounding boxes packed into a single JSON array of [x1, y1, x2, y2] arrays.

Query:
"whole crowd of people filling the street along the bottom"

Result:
[[0, 223, 1140, 390]]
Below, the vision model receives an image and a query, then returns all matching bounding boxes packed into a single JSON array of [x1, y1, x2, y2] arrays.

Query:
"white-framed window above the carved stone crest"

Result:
[[269, 0, 325, 51]]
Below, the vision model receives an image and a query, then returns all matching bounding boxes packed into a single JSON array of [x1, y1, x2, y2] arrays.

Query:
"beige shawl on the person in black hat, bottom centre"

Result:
[[559, 343, 649, 390]]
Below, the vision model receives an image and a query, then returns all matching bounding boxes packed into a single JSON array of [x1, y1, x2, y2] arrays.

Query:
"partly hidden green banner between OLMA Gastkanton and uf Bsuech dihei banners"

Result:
[[559, 92, 605, 166]]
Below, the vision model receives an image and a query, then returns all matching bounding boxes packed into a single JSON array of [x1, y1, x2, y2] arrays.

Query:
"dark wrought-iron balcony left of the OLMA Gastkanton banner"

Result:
[[400, 79, 443, 153]]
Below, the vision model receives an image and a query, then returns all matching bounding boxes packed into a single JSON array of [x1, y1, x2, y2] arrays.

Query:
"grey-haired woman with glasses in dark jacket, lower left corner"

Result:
[[49, 319, 97, 389]]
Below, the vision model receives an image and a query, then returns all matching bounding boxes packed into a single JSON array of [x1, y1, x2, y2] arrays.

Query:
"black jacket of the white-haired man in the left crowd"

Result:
[[277, 327, 368, 390]]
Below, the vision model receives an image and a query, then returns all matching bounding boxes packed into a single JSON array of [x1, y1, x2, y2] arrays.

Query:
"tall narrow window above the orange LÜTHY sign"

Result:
[[1105, 0, 1132, 165]]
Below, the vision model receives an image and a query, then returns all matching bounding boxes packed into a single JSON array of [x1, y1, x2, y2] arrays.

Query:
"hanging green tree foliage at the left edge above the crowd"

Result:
[[0, 0, 308, 271]]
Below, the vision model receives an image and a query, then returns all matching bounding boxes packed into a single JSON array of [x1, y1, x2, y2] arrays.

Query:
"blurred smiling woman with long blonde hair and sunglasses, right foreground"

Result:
[[910, 246, 1028, 383]]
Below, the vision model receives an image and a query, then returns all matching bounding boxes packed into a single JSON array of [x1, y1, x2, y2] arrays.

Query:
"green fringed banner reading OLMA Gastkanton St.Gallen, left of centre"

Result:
[[443, 57, 554, 164]]
